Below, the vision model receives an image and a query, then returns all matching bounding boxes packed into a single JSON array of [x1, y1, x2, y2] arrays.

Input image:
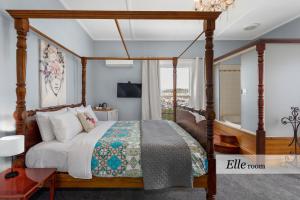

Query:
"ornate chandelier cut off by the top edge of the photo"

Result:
[[194, 0, 235, 12]]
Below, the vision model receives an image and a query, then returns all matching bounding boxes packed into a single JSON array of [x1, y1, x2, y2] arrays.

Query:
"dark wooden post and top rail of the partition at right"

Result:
[[214, 38, 300, 155]]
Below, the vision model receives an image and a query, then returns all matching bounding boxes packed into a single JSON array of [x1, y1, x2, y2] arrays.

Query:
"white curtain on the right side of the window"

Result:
[[189, 57, 205, 110]]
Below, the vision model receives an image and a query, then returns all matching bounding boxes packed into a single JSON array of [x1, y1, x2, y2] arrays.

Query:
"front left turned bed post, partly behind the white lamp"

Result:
[[14, 18, 29, 166]]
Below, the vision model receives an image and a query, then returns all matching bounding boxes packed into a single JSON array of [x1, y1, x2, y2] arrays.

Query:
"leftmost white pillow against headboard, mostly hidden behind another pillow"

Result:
[[36, 108, 67, 142]]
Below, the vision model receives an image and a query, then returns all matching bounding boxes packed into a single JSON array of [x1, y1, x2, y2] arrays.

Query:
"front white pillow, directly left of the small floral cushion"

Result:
[[49, 111, 83, 142]]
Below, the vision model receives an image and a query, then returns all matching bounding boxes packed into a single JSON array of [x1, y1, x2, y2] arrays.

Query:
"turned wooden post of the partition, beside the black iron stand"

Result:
[[256, 42, 266, 155]]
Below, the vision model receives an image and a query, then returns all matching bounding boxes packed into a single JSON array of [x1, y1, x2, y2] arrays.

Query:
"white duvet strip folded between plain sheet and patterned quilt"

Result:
[[68, 121, 115, 179]]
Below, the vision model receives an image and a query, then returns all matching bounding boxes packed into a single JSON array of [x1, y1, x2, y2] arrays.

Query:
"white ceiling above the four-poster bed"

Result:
[[60, 0, 300, 40]]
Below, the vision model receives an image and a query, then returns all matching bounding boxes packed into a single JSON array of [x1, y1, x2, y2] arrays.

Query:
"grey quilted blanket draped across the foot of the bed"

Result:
[[141, 120, 193, 190]]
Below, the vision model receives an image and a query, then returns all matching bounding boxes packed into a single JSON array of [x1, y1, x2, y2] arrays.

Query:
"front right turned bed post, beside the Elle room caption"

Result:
[[203, 20, 217, 200]]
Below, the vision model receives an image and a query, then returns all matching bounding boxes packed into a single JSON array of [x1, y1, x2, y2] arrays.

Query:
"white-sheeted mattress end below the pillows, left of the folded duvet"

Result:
[[25, 134, 80, 172]]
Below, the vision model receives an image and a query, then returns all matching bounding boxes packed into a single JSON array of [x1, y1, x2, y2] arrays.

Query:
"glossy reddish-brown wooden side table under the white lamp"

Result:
[[0, 168, 56, 200]]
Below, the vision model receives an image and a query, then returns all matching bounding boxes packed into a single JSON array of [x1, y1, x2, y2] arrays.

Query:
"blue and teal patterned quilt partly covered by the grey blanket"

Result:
[[91, 121, 207, 177]]
